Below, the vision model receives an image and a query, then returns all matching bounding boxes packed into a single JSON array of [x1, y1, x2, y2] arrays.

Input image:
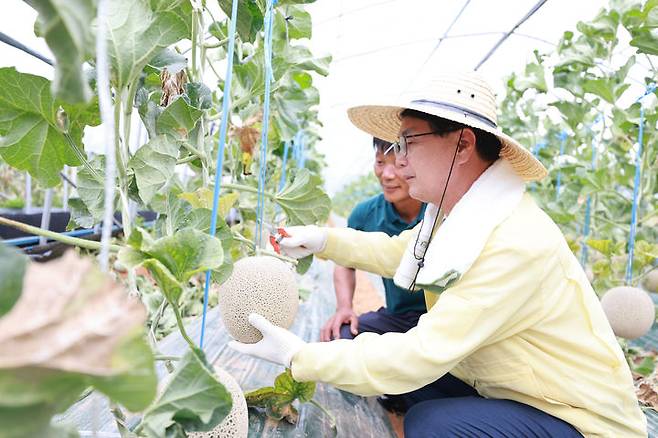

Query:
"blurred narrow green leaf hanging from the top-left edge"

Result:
[[27, 0, 96, 103]]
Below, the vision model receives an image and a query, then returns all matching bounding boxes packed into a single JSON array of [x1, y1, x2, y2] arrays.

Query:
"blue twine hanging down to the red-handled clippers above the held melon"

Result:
[[254, 0, 277, 248]]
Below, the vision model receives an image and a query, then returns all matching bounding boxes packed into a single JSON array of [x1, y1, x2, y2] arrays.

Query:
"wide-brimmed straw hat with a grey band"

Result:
[[347, 72, 548, 181]]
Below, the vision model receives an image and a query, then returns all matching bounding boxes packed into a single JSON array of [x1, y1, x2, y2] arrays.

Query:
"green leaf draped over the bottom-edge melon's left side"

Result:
[[138, 349, 232, 438]]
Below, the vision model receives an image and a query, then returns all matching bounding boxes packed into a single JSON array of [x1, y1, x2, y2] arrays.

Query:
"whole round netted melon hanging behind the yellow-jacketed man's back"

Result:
[[601, 286, 656, 339]]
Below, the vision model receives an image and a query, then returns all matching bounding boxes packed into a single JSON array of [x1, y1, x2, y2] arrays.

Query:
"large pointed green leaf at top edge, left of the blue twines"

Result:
[[107, 0, 192, 89]]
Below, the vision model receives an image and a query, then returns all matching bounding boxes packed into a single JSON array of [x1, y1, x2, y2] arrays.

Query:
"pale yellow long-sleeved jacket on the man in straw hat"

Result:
[[292, 195, 647, 438]]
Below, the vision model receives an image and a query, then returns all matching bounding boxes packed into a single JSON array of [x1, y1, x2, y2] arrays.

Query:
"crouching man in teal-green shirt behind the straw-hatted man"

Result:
[[320, 137, 427, 341]]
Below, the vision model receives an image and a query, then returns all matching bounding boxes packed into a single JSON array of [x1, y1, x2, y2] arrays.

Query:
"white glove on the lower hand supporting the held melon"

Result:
[[228, 313, 306, 368]]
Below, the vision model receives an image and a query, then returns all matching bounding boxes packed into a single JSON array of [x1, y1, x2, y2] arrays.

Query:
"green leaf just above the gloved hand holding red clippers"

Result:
[[275, 169, 331, 225]]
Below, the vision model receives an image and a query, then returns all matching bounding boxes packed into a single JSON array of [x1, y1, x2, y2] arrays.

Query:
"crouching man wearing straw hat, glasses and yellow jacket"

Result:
[[231, 73, 647, 438]]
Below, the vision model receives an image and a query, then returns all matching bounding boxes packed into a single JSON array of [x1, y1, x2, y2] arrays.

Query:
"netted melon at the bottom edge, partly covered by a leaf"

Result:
[[187, 367, 249, 438]]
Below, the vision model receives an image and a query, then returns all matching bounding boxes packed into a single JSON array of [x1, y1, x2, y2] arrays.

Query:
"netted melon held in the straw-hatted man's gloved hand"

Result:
[[219, 256, 299, 344]]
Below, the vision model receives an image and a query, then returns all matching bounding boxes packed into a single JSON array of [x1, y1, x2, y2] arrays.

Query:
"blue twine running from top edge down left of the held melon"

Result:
[[199, 0, 238, 349]]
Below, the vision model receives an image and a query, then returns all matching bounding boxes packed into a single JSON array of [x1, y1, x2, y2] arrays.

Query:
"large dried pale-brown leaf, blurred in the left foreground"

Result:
[[0, 252, 146, 376]]
